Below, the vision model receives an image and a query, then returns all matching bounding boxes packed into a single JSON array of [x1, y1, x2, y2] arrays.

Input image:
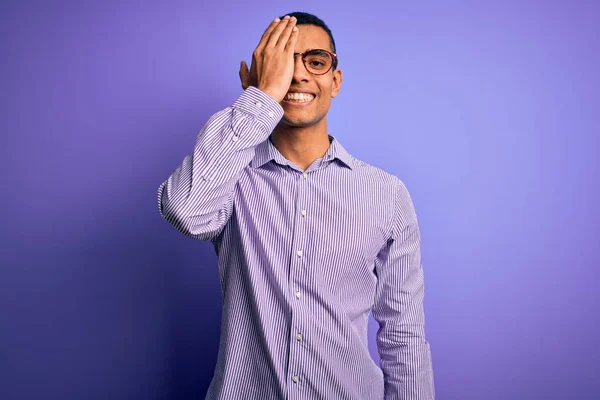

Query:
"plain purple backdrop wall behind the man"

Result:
[[0, 0, 600, 400]]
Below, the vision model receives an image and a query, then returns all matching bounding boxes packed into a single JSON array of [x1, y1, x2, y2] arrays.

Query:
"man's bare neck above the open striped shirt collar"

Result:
[[271, 121, 330, 171]]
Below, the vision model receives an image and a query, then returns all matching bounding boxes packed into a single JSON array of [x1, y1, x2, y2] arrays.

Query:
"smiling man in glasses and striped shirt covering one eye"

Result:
[[158, 13, 434, 400]]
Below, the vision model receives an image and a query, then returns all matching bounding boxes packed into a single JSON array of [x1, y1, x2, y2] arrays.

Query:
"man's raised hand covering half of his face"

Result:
[[240, 16, 298, 103]]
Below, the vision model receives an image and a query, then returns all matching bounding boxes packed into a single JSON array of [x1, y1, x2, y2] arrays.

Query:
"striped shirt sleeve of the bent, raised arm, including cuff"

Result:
[[158, 86, 283, 240]]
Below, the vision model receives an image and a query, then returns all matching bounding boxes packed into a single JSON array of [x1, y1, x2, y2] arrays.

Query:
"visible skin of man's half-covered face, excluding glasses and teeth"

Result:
[[281, 25, 342, 127]]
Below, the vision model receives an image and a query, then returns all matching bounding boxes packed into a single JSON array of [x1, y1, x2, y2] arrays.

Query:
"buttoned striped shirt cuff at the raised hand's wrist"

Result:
[[233, 86, 283, 132]]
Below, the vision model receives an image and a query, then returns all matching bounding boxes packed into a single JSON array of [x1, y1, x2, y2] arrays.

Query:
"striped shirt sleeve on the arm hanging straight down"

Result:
[[373, 179, 435, 400]]
